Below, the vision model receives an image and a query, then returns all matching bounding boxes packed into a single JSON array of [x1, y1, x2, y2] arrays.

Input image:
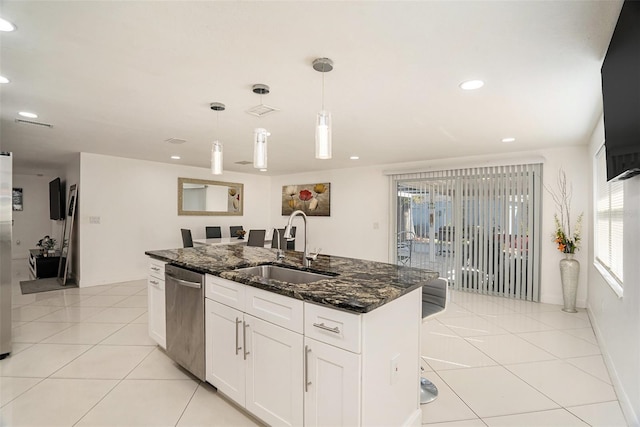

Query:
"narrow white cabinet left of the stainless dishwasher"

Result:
[[147, 259, 167, 348]]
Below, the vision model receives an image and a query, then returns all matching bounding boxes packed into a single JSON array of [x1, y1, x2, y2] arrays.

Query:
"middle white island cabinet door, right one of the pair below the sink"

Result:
[[245, 314, 303, 426]]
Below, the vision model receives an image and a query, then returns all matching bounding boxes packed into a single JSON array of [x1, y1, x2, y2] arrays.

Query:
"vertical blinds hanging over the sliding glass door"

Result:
[[391, 164, 542, 301]]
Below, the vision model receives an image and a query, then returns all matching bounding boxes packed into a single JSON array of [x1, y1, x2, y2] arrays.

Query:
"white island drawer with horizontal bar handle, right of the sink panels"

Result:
[[304, 303, 362, 353]]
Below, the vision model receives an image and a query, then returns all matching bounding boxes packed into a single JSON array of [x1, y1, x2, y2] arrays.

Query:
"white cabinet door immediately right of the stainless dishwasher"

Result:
[[205, 298, 245, 406]]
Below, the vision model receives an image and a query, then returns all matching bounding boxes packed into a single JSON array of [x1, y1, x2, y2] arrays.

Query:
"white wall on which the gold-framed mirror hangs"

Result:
[[76, 153, 271, 286]]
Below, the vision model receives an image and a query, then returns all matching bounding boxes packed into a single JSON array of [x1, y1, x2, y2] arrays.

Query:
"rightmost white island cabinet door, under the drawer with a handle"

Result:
[[304, 338, 361, 426]]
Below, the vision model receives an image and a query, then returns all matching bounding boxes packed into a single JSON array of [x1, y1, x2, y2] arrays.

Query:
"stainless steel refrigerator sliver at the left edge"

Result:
[[0, 152, 13, 359]]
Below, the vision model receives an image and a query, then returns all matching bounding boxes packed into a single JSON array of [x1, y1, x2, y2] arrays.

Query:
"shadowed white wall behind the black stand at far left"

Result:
[[11, 173, 64, 259]]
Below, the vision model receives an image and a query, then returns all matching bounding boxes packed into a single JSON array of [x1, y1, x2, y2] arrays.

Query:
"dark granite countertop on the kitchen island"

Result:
[[145, 245, 438, 313]]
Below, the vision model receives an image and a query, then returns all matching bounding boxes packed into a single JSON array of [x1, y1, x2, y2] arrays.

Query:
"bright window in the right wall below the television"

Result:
[[594, 145, 624, 296]]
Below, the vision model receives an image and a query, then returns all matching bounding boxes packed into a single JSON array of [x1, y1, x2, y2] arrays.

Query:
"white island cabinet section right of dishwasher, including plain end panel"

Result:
[[205, 275, 421, 426]]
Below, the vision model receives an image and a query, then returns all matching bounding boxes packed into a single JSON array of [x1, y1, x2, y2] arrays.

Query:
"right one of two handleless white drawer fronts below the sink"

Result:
[[244, 286, 304, 334]]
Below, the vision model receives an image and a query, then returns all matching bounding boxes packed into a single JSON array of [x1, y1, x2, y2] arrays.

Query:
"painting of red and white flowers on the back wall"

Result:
[[282, 182, 331, 216]]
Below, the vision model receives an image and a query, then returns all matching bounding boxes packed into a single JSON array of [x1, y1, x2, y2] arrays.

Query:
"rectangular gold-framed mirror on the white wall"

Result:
[[178, 178, 244, 215]]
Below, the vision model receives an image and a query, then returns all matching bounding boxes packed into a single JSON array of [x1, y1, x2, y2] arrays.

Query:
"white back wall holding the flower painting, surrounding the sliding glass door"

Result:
[[271, 146, 591, 307]]
